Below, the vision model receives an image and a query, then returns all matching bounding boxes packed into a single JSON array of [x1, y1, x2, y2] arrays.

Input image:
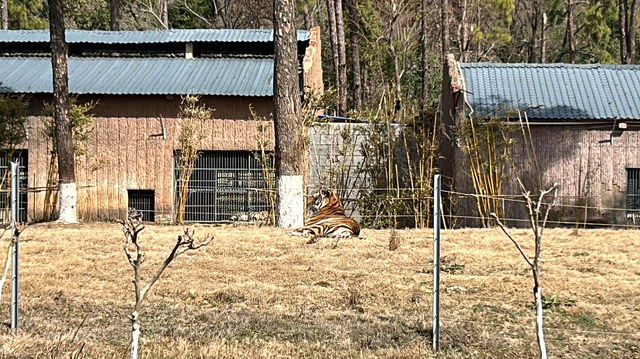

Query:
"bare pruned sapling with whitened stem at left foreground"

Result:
[[120, 209, 213, 359]]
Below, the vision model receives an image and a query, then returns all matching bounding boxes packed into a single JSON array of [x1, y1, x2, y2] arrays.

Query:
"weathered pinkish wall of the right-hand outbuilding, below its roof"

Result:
[[456, 125, 640, 225]]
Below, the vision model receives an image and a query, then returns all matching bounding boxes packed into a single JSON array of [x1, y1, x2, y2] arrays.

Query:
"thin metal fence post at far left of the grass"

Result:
[[11, 162, 20, 330]]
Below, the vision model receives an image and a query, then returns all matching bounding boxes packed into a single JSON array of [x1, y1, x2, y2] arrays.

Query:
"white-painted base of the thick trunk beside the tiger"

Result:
[[278, 176, 304, 228]]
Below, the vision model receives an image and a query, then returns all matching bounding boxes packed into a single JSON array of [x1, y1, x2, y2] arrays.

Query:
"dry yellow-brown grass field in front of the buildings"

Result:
[[0, 223, 640, 358]]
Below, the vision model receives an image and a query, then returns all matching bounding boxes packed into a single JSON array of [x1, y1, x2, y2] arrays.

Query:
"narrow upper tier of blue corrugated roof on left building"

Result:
[[0, 29, 309, 44]]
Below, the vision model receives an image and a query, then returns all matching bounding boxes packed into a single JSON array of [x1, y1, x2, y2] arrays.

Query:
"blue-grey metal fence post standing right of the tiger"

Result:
[[432, 174, 441, 352]]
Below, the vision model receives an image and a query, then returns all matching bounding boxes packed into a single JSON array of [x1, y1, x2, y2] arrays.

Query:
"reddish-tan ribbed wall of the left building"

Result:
[[23, 117, 274, 221]]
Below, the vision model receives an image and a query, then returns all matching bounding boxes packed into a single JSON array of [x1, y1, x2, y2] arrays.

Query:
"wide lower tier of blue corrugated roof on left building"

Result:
[[0, 57, 273, 96]]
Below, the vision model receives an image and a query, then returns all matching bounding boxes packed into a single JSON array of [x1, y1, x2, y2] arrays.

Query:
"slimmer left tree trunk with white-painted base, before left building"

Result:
[[49, 0, 78, 223]]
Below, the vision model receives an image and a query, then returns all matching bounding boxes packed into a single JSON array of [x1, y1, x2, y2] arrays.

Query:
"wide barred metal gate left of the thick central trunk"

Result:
[[174, 151, 274, 222]]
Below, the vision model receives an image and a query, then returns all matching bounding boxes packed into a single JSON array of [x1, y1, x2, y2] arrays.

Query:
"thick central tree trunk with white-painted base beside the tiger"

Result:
[[273, 0, 305, 227]]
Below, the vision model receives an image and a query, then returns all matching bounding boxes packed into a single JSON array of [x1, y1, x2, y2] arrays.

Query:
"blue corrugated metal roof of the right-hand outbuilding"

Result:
[[460, 63, 640, 120]]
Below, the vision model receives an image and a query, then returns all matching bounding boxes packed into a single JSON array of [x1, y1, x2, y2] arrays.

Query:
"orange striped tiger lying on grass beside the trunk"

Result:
[[292, 190, 360, 237]]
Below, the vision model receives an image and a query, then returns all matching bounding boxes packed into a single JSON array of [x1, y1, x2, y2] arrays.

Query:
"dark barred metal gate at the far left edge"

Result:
[[0, 150, 29, 224]]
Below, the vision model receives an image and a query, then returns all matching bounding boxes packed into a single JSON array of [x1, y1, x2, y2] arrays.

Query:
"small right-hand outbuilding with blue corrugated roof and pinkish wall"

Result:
[[441, 55, 640, 225]]
